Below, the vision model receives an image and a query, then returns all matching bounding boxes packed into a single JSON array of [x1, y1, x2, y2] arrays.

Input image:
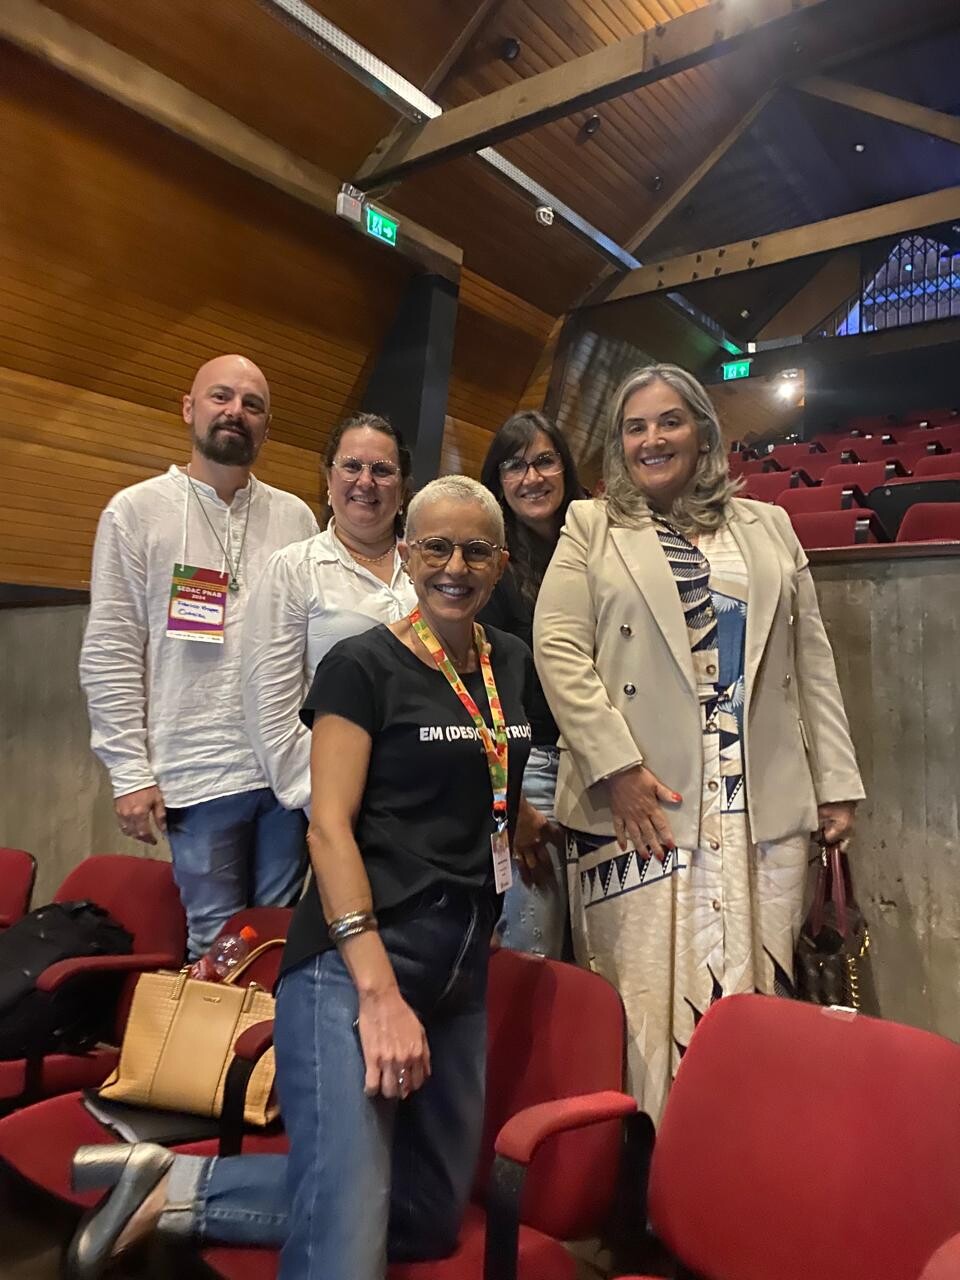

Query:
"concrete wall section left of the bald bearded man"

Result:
[[0, 605, 169, 905]]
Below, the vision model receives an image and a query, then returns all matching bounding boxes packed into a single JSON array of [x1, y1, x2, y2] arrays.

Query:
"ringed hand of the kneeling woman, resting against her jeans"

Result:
[[357, 987, 430, 1098]]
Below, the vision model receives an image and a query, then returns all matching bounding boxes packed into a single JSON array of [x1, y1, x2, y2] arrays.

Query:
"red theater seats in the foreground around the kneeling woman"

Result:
[[0, 856, 960, 1280]]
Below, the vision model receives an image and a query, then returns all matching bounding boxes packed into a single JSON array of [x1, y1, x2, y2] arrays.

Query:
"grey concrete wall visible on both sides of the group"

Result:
[[0, 554, 960, 1039]]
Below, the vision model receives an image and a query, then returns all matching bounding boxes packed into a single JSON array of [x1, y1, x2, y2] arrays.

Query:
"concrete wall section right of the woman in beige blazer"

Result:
[[814, 554, 960, 1039]]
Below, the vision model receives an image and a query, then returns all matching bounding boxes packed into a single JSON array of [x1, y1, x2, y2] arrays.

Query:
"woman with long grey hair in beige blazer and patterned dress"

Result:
[[534, 365, 864, 1120]]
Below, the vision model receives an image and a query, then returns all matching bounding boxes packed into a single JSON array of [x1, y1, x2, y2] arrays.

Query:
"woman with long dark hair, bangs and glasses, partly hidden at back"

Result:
[[480, 411, 584, 959]]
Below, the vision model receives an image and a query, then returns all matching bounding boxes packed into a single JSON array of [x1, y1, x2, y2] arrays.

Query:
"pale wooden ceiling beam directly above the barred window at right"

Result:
[[600, 187, 960, 306]]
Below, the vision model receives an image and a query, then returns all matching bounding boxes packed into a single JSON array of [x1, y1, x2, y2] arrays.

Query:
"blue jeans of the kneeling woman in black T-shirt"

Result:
[[161, 887, 497, 1280]]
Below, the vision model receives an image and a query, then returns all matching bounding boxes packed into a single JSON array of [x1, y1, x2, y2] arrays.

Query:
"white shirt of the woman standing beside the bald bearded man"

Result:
[[243, 521, 416, 809]]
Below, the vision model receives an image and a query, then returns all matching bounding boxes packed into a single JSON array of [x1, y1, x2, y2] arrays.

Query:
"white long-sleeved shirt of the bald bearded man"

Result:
[[79, 466, 317, 808]]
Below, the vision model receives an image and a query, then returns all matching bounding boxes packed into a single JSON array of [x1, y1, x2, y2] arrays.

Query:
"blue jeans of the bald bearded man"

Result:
[[166, 787, 307, 960]]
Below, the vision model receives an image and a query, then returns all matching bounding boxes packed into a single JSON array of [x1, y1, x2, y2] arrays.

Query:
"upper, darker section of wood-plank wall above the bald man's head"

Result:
[[0, 49, 410, 448]]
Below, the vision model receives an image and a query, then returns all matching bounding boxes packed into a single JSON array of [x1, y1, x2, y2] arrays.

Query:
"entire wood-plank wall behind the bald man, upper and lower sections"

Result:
[[0, 46, 410, 588]]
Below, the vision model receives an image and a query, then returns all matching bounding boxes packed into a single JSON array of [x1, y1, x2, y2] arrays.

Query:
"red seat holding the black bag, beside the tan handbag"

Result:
[[0, 854, 186, 1107]]
